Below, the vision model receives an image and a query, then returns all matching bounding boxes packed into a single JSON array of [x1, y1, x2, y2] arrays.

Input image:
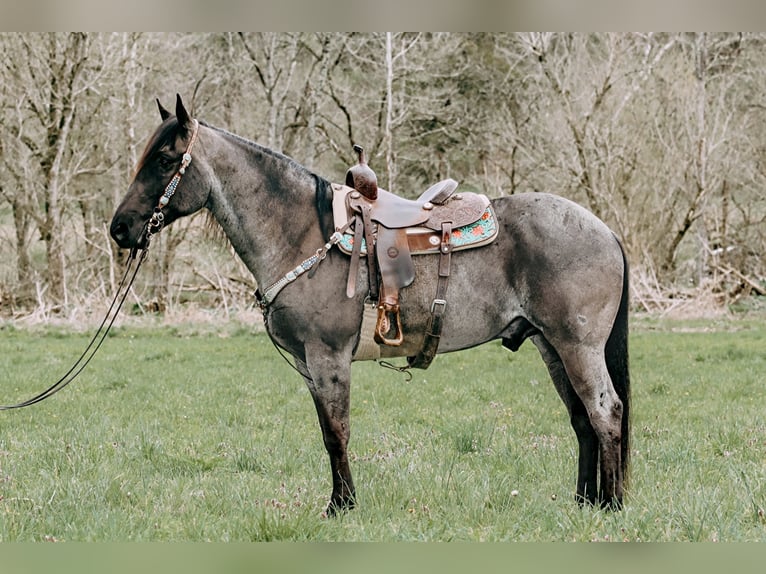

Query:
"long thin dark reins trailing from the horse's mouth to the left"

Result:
[[0, 250, 148, 411]]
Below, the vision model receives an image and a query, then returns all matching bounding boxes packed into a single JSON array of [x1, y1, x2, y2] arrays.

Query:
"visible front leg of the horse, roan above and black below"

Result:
[[298, 349, 356, 516]]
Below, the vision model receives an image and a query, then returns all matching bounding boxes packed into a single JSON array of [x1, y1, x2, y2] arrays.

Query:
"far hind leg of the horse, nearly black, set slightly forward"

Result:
[[531, 335, 599, 504]]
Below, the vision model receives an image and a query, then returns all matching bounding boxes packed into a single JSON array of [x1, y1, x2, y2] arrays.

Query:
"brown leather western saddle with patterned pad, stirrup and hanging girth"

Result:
[[333, 145, 497, 369]]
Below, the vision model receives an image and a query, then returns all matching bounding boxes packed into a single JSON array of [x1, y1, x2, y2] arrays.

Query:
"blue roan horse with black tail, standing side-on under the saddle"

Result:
[[110, 95, 630, 515]]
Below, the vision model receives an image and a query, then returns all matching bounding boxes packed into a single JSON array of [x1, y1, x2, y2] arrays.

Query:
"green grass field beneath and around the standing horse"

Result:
[[0, 319, 766, 541]]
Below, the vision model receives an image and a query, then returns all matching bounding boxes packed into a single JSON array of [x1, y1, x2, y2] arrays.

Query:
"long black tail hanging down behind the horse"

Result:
[[605, 237, 630, 492]]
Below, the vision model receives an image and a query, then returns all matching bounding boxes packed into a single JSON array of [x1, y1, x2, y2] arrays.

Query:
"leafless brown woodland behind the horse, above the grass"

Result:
[[0, 33, 766, 318]]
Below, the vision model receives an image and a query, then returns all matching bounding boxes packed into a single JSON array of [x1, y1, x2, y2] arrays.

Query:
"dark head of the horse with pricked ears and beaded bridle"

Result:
[[110, 96, 210, 248]]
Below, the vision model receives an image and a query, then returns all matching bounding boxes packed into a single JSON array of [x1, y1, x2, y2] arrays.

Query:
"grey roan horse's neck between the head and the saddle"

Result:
[[208, 132, 329, 287]]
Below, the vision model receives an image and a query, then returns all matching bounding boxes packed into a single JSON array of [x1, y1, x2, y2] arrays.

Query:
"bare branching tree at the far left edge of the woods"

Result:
[[3, 34, 97, 303]]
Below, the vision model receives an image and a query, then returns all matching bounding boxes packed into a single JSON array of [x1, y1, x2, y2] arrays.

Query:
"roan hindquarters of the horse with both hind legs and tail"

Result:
[[498, 194, 629, 506]]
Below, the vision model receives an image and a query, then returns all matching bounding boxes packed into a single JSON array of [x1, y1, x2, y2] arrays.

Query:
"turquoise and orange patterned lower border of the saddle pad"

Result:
[[338, 205, 498, 255]]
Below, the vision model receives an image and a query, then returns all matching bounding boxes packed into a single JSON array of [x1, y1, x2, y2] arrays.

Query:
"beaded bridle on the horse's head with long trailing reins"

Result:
[[0, 119, 199, 411]]
